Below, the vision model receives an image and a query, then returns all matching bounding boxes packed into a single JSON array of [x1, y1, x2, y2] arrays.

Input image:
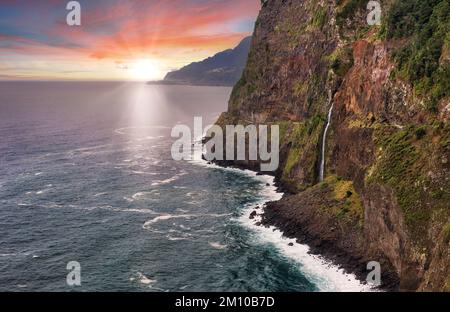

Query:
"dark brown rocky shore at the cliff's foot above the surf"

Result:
[[214, 161, 399, 291]]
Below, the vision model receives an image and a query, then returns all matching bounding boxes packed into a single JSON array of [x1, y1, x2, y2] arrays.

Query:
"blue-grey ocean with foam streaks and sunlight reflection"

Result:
[[0, 82, 368, 292]]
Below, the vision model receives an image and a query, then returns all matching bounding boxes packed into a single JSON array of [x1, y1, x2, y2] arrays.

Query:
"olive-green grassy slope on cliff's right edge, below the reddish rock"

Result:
[[366, 122, 450, 242]]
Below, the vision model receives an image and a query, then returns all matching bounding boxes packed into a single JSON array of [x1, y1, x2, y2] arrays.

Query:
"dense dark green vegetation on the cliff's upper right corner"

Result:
[[383, 0, 450, 111]]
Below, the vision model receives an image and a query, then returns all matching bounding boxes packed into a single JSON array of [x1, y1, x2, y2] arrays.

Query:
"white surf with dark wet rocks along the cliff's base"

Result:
[[192, 149, 378, 292]]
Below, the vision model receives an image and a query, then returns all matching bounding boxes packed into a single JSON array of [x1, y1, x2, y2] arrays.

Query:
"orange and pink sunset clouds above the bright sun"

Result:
[[0, 0, 260, 80]]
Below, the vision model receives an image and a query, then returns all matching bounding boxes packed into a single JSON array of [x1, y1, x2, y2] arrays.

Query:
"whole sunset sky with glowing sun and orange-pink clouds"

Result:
[[0, 0, 260, 80]]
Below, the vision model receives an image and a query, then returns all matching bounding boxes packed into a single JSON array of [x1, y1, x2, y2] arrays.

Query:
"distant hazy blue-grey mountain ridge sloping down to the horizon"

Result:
[[162, 37, 252, 86]]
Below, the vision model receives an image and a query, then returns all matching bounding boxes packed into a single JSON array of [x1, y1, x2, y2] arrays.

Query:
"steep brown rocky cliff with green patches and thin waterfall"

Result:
[[218, 0, 450, 290]]
